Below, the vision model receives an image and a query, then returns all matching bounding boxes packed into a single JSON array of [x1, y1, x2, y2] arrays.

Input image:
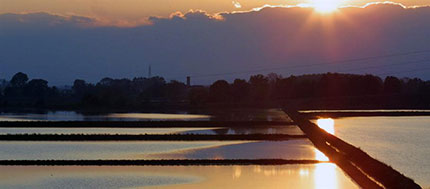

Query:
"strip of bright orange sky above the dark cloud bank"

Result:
[[0, 0, 430, 25]]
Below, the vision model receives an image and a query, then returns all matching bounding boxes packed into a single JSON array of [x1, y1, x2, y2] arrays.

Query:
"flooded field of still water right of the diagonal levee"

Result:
[[334, 116, 430, 188]]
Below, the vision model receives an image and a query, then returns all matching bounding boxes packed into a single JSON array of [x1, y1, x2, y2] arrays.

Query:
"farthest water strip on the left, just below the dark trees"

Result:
[[0, 109, 291, 121]]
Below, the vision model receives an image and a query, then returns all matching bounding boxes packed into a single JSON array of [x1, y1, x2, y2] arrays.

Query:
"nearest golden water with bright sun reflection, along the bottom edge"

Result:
[[0, 163, 357, 189]]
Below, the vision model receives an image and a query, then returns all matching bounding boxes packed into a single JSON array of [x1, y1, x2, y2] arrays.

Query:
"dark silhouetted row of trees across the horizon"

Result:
[[0, 72, 430, 110]]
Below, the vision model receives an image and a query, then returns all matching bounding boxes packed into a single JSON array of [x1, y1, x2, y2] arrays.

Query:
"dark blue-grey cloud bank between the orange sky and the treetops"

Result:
[[0, 4, 430, 84]]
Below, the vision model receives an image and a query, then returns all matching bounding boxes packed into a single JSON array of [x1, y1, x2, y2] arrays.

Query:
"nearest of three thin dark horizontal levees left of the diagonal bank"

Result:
[[0, 159, 325, 166]]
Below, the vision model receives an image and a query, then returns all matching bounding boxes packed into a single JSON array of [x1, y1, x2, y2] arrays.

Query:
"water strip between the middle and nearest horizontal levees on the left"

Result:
[[0, 139, 316, 160]]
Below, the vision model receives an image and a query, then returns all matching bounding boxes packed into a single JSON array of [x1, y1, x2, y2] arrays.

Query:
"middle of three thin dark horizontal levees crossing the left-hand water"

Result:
[[0, 134, 306, 141]]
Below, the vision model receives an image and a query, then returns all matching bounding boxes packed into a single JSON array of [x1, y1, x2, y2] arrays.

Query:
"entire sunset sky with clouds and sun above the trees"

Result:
[[0, 0, 430, 85]]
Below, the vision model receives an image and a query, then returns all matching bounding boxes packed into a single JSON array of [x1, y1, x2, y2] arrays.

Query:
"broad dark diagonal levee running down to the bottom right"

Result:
[[286, 111, 421, 189]]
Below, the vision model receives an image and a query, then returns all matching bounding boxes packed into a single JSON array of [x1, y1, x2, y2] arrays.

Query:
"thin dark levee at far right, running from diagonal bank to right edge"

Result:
[[301, 111, 430, 119]]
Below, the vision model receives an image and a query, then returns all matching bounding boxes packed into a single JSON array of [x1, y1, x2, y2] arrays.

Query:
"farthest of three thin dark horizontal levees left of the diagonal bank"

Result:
[[0, 121, 294, 128]]
